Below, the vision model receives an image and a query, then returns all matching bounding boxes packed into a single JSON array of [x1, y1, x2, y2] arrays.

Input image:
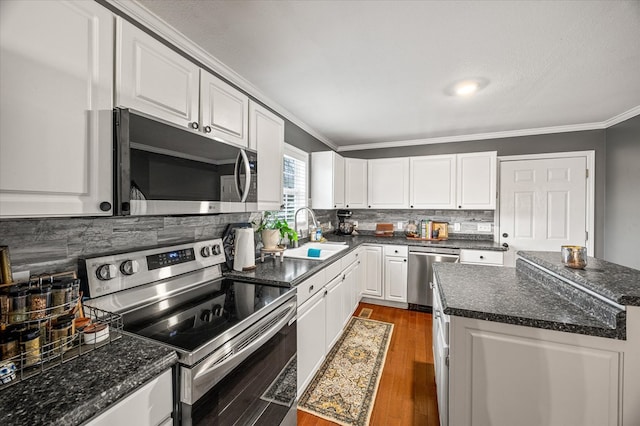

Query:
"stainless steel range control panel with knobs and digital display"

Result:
[[78, 239, 225, 298]]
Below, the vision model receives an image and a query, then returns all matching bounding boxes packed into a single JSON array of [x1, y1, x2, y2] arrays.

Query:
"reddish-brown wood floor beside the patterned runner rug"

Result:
[[298, 303, 438, 426]]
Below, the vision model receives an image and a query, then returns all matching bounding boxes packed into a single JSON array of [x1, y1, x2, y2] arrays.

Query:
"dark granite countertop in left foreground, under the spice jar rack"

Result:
[[0, 335, 178, 426]]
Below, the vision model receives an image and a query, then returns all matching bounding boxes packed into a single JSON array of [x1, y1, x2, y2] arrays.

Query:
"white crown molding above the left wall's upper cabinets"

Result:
[[105, 0, 338, 151]]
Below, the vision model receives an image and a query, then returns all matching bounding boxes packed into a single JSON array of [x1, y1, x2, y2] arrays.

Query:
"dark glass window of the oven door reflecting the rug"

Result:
[[182, 322, 296, 426]]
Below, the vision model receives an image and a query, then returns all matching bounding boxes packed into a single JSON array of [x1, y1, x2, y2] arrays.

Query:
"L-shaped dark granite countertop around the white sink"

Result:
[[224, 234, 506, 287]]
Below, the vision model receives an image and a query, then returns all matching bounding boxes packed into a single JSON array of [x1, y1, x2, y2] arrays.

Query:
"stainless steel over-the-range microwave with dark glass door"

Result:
[[114, 108, 258, 216]]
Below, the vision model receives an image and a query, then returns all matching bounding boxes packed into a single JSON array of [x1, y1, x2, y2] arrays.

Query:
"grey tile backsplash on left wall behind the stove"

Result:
[[0, 213, 260, 275]]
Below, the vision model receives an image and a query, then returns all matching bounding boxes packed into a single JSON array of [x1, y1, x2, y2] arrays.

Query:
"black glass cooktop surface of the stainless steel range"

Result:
[[123, 280, 295, 352]]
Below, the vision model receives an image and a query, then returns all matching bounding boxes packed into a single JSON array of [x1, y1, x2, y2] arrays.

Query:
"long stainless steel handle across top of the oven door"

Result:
[[181, 299, 296, 404]]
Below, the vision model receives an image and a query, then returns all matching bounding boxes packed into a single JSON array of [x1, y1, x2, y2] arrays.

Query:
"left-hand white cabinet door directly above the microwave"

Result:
[[115, 18, 200, 128]]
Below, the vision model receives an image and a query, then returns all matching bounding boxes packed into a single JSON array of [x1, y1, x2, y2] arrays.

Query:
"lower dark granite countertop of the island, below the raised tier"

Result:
[[434, 263, 626, 339]]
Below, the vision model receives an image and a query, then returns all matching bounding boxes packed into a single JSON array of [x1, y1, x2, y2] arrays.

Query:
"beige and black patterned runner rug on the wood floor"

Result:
[[298, 317, 393, 426]]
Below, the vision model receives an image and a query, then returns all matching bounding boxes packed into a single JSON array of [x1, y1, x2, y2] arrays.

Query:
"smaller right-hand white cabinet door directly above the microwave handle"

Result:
[[200, 70, 249, 149]]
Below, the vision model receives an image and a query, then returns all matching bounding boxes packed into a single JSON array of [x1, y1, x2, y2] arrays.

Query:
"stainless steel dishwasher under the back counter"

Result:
[[407, 246, 460, 312]]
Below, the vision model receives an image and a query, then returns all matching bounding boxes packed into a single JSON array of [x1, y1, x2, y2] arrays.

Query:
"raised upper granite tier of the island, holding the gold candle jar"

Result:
[[518, 251, 640, 306]]
